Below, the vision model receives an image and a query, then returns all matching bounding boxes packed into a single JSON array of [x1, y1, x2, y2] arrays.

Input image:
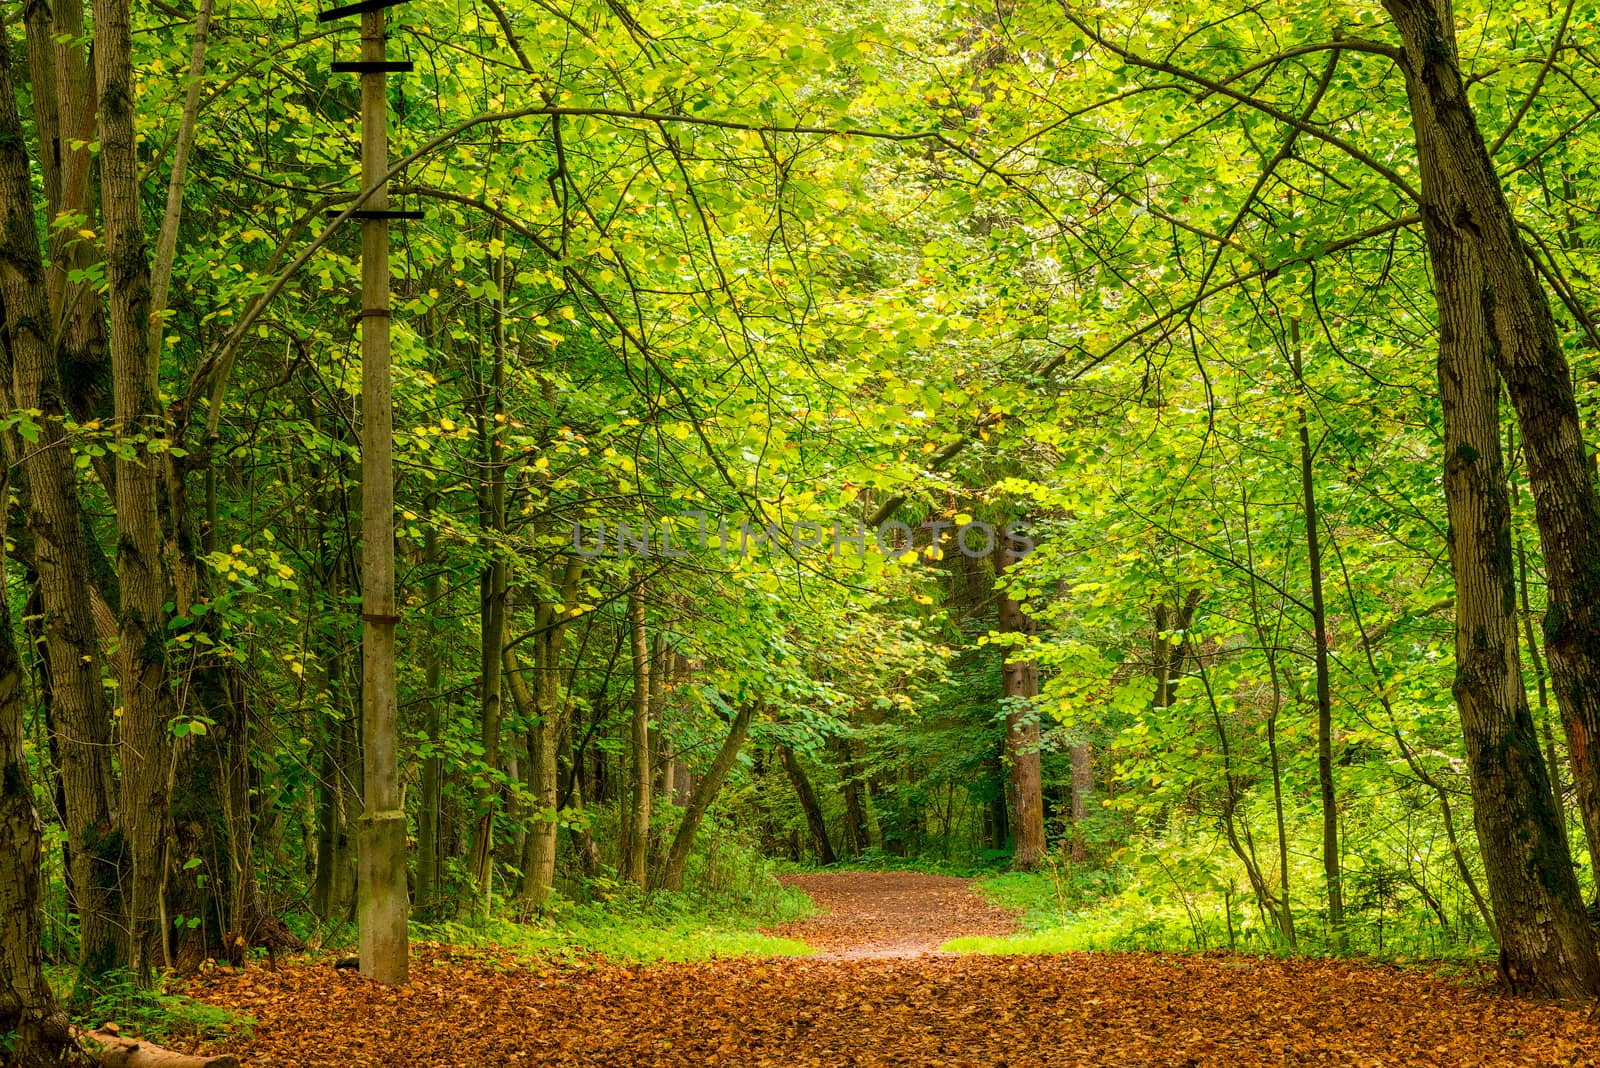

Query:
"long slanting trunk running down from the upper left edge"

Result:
[[0, 22, 126, 975]]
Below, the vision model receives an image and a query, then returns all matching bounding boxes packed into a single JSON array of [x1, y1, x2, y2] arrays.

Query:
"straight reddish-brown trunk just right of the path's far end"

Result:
[[995, 539, 1045, 871]]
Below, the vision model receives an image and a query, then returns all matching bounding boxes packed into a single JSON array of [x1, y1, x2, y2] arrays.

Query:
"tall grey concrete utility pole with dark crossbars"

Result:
[[318, 0, 413, 985]]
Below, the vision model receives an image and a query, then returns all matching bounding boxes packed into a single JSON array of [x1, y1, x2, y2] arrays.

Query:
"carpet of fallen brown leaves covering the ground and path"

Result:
[[181, 873, 1600, 1068]]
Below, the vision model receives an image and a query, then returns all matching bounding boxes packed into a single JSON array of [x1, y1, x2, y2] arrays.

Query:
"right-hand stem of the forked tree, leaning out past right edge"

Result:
[[1386, 0, 1600, 901]]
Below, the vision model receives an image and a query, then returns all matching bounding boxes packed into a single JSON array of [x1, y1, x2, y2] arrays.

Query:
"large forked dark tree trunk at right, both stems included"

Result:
[[1384, 0, 1600, 996]]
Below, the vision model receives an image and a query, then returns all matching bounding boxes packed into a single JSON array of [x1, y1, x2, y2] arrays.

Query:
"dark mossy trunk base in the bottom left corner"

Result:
[[0, 546, 70, 1068]]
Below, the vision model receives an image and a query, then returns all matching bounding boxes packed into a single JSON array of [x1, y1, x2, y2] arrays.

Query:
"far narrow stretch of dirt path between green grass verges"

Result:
[[779, 871, 1016, 961]]
